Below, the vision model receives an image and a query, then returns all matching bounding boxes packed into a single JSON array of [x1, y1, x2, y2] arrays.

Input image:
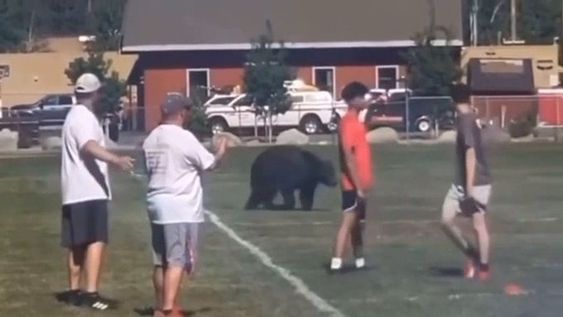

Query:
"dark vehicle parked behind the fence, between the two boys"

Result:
[[365, 94, 455, 132]]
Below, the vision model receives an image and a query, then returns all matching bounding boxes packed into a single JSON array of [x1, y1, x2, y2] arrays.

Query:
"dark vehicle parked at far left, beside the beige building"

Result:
[[10, 94, 76, 126]]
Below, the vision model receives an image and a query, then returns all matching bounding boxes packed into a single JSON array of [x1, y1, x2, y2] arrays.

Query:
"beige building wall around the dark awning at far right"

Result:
[[461, 45, 562, 88]]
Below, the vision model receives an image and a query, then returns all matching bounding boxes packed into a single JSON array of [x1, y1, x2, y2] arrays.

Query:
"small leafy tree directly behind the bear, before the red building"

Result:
[[244, 21, 292, 141]]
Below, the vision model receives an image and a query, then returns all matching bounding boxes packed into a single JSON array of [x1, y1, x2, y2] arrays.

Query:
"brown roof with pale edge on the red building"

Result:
[[122, 0, 463, 52]]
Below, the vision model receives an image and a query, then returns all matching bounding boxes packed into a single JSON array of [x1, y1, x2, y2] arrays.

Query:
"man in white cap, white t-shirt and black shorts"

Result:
[[57, 73, 133, 310]]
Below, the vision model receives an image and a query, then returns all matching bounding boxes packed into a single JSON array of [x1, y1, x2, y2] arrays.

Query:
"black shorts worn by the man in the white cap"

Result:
[[61, 200, 108, 248]]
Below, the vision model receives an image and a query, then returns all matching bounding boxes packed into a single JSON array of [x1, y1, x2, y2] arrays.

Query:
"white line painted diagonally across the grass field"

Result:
[[205, 210, 346, 317]]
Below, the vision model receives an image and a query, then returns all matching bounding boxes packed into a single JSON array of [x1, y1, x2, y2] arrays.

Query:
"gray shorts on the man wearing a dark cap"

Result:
[[151, 223, 199, 271]]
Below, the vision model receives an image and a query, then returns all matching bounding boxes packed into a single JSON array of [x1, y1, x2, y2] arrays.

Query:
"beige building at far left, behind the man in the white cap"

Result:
[[0, 38, 137, 107]]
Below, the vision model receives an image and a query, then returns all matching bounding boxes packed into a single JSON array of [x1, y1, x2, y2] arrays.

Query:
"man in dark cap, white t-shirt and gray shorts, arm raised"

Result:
[[143, 94, 227, 316]]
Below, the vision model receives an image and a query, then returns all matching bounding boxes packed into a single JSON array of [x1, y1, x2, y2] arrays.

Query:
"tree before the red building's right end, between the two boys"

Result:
[[403, 0, 462, 96]]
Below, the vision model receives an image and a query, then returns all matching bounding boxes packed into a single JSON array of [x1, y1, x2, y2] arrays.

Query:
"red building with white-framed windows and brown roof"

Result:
[[121, 0, 463, 130]]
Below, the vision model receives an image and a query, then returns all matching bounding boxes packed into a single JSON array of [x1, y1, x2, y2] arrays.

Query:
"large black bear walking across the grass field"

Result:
[[246, 145, 337, 210]]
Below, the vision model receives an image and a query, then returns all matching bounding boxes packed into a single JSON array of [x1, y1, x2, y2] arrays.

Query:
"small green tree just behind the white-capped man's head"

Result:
[[65, 51, 127, 112]]
